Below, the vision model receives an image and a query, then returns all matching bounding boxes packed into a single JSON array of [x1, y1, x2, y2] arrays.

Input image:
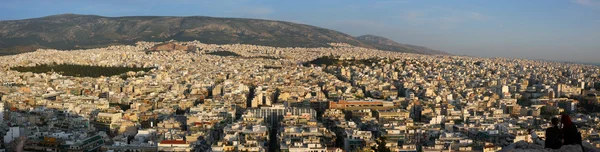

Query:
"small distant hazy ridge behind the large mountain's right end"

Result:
[[356, 35, 450, 55]]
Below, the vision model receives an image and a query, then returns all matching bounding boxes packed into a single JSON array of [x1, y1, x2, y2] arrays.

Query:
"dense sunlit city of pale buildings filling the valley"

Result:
[[0, 41, 600, 152]]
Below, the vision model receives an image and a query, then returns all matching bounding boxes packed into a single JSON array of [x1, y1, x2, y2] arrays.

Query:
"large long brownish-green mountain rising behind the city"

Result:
[[0, 14, 446, 55]]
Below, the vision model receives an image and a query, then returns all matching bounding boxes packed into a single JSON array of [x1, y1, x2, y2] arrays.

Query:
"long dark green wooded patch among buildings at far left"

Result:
[[10, 64, 153, 77]]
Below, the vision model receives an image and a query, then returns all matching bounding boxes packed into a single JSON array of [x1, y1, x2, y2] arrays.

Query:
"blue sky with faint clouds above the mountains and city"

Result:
[[0, 0, 600, 63]]
